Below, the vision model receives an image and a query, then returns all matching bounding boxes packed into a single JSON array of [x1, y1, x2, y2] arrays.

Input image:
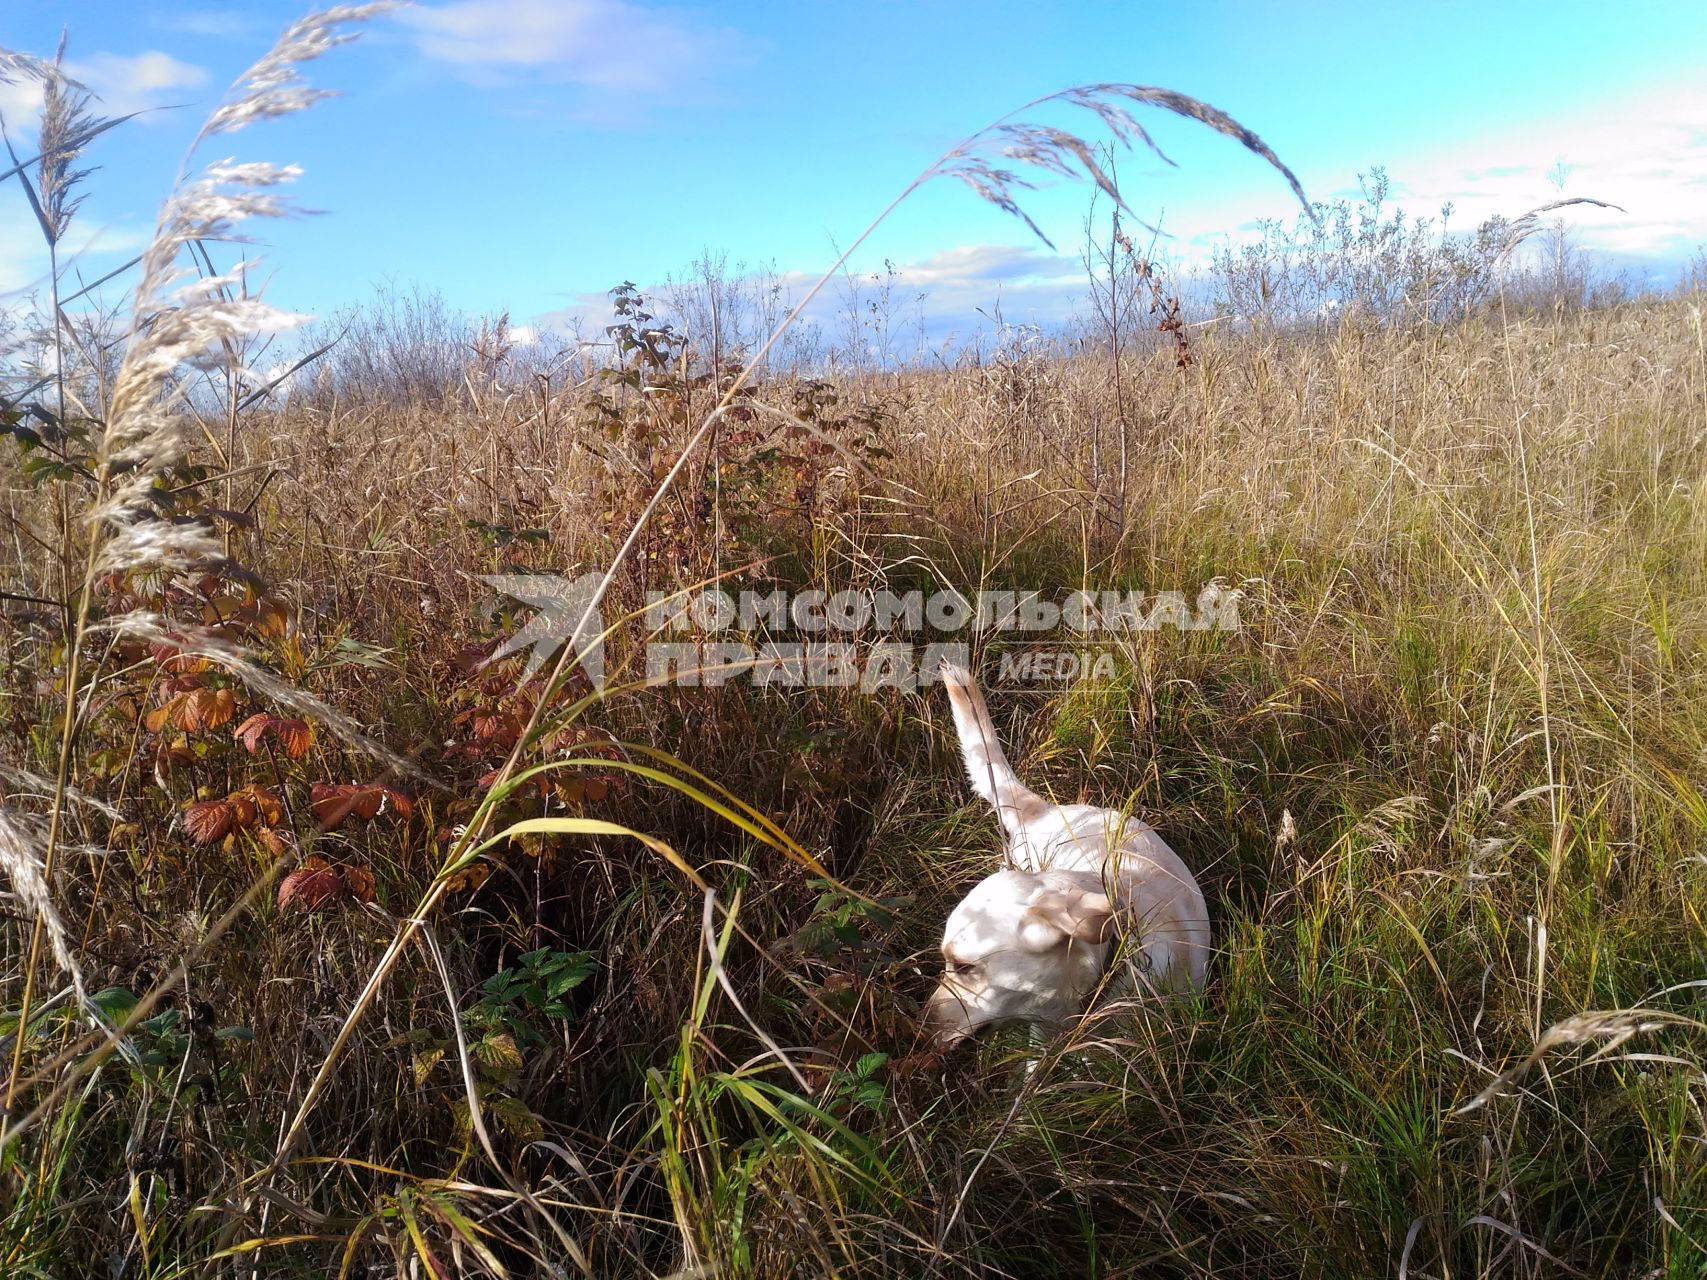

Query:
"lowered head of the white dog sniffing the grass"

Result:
[[923, 870, 1115, 1048]]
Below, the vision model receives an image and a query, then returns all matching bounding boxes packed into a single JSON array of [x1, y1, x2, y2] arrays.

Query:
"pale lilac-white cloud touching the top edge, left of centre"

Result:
[[401, 0, 751, 94]]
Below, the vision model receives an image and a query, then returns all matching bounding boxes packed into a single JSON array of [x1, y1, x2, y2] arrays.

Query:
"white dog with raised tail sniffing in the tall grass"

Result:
[[923, 666, 1210, 1048]]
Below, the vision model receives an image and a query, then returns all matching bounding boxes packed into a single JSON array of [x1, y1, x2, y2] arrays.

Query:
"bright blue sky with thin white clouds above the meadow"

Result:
[[0, 0, 1707, 346]]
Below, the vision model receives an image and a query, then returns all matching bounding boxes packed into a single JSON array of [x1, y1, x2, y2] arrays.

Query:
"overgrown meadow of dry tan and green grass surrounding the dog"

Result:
[[0, 10, 1707, 1280]]
